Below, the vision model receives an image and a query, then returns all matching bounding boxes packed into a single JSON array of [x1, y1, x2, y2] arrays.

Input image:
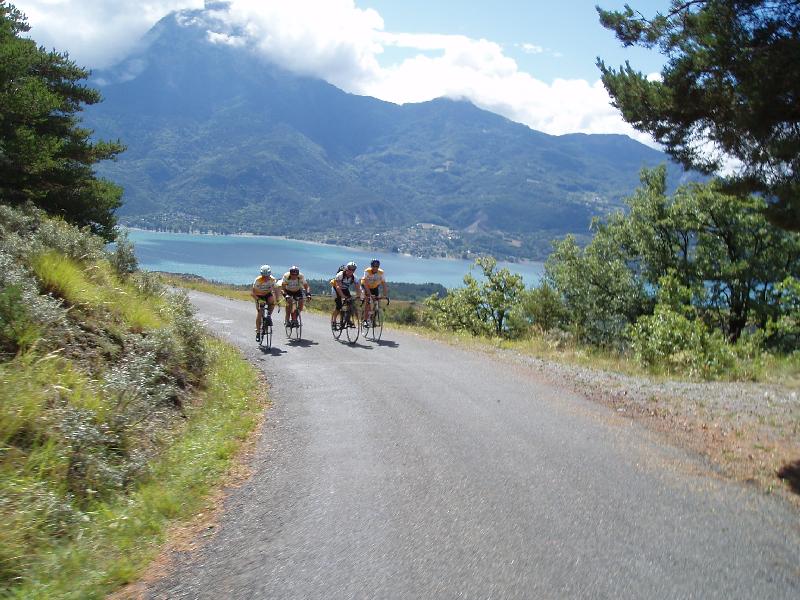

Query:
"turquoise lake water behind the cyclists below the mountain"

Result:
[[129, 230, 543, 288]]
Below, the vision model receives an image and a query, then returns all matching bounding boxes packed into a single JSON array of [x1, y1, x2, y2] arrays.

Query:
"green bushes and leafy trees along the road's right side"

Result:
[[421, 169, 800, 379]]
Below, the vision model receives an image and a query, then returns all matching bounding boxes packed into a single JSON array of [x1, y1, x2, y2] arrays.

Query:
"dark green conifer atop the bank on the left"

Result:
[[0, 0, 124, 240]]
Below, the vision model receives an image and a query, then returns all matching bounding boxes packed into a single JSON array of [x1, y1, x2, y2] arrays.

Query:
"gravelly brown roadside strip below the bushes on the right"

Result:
[[493, 349, 800, 507]]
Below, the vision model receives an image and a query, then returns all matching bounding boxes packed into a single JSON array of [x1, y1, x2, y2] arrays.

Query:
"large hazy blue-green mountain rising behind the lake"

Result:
[[85, 6, 683, 258]]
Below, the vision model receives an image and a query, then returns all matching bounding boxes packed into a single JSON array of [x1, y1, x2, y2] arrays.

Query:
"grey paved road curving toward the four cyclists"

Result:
[[148, 294, 800, 600]]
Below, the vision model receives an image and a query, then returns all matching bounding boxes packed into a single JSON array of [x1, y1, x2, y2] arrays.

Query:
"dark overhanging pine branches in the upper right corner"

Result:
[[597, 0, 800, 231]]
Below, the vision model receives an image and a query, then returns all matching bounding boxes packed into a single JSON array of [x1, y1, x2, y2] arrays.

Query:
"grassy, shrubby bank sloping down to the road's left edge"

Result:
[[0, 206, 260, 598]]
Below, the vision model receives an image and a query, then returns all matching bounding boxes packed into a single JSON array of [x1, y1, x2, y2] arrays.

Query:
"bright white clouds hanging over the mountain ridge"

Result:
[[18, 0, 652, 145]]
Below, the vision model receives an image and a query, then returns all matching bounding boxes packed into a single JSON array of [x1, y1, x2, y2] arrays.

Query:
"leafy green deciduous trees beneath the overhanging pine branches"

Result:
[[546, 168, 800, 343]]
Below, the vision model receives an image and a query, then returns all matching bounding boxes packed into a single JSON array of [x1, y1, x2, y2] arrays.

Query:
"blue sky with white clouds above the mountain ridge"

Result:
[[11, 0, 669, 146]]
